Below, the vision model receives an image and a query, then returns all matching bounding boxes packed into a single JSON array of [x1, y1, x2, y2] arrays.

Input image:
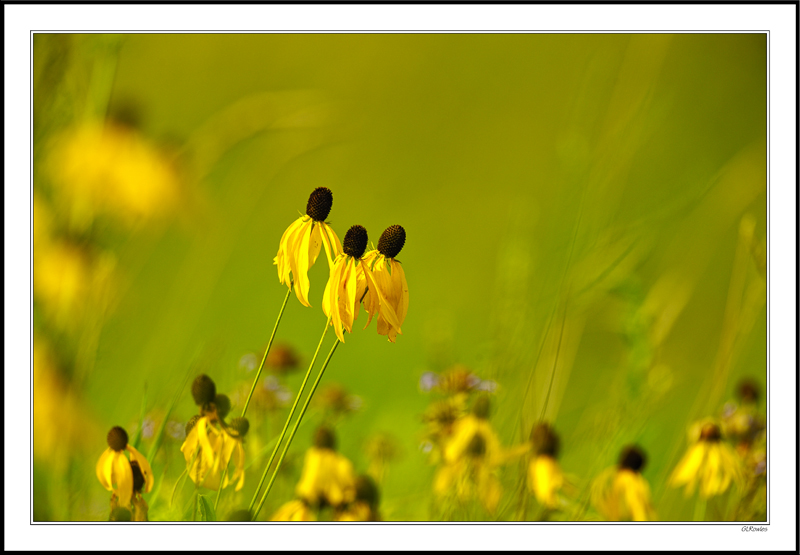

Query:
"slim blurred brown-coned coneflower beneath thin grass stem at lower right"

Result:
[[528, 422, 564, 509]]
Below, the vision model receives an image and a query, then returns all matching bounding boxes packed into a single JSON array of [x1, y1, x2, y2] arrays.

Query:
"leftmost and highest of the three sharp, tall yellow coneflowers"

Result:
[[274, 187, 342, 307]]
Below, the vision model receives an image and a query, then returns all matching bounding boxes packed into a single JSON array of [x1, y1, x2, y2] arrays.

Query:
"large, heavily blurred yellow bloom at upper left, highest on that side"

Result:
[[47, 122, 180, 227]]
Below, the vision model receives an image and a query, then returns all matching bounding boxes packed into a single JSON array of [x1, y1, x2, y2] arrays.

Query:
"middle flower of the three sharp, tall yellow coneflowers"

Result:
[[322, 225, 400, 343]]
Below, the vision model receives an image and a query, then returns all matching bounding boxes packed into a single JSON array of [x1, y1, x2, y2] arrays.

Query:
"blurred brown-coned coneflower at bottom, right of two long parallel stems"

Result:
[[295, 427, 356, 508]]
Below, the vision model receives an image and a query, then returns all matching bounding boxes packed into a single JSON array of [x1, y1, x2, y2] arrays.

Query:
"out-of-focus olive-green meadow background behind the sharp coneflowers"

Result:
[[33, 34, 767, 521]]
